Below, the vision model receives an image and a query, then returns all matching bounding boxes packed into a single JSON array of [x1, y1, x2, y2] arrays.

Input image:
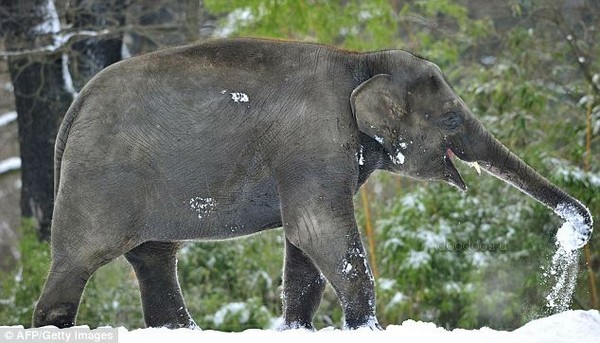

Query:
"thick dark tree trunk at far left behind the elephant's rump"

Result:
[[1, 0, 73, 239]]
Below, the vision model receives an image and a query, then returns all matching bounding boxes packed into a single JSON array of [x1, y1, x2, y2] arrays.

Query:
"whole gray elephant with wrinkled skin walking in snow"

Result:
[[33, 39, 592, 329]]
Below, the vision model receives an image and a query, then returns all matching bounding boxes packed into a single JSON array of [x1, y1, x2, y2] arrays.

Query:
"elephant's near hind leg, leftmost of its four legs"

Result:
[[33, 193, 137, 327]]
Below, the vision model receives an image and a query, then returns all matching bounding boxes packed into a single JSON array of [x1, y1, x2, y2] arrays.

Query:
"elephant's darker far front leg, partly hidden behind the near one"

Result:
[[280, 239, 325, 330]]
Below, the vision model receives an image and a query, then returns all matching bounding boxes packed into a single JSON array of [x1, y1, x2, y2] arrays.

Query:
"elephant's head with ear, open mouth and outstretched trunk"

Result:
[[351, 55, 592, 249]]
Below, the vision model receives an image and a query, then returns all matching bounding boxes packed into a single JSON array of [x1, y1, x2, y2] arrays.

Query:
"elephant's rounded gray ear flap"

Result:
[[350, 74, 405, 152]]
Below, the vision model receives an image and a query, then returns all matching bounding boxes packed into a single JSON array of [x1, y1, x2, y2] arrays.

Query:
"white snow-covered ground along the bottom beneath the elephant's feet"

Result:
[[0, 310, 600, 343]]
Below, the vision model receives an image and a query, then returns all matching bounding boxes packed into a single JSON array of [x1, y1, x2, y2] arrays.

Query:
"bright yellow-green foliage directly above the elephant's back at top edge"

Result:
[[204, 0, 397, 50]]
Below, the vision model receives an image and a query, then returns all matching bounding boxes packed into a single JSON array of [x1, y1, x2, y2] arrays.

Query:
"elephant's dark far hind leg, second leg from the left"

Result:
[[125, 242, 197, 329]]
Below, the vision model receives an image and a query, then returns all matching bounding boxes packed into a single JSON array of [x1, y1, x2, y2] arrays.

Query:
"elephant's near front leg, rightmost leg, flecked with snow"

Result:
[[280, 177, 381, 330]]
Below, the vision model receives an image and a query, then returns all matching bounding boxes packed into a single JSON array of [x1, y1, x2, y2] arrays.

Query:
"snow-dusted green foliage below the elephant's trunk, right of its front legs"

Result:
[[368, 168, 558, 329]]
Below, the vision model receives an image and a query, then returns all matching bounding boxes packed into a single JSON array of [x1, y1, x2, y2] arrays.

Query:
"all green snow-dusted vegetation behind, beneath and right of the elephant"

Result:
[[0, 0, 600, 330]]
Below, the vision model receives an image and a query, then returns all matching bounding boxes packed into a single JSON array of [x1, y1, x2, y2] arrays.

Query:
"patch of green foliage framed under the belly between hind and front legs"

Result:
[[178, 230, 283, 331]]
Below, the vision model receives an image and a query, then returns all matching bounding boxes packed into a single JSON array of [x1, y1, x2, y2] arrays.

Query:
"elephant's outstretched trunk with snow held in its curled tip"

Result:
[[459, 124, 593, 250]]
